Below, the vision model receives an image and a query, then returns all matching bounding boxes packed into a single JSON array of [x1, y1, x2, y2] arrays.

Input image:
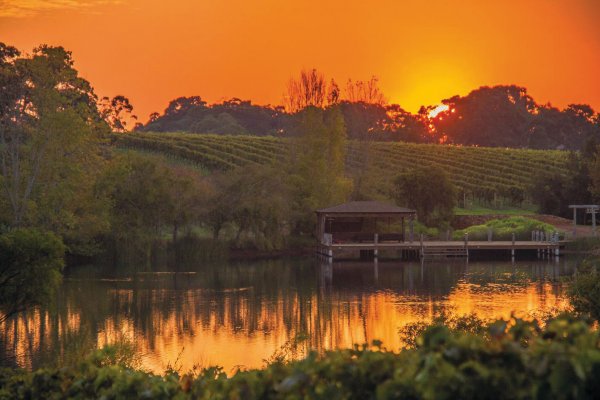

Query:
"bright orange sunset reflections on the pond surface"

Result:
[[0, 274, 569, 373]]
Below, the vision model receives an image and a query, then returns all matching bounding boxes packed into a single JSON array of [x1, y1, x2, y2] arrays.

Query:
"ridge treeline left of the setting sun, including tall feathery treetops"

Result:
[[136, 69, 432, 142]]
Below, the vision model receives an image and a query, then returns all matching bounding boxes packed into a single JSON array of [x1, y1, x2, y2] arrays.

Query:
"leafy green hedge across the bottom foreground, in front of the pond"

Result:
[[0, 316, 600, 399]]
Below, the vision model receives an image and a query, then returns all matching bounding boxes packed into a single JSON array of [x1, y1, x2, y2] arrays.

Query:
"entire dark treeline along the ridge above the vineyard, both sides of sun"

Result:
[[136, 69, 600, 150]]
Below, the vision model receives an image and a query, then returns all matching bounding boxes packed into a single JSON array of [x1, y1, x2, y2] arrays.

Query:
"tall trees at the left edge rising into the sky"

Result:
[[0, 43, 109, 253]]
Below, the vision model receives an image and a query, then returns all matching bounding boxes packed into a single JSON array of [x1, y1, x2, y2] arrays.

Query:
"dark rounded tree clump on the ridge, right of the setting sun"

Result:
[[431, 85, 600, 150]]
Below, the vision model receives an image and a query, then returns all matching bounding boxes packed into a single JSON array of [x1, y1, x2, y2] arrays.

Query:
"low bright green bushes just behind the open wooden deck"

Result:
[[453, 217, 556, 240]]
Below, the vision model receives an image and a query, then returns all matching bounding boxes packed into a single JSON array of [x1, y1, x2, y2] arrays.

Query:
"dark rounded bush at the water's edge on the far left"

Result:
[[0, 229, 65, 321]]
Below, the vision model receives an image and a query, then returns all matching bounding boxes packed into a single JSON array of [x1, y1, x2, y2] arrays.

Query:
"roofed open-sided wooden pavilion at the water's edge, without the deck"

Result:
[[316, 201, 417, 246]]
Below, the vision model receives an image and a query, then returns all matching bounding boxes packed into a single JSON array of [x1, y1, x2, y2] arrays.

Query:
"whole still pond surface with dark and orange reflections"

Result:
[[0, 258, 574, 373]]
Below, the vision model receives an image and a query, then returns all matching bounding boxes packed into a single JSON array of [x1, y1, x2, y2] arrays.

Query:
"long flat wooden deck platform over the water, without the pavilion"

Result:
[[317, 240, 564, 259]]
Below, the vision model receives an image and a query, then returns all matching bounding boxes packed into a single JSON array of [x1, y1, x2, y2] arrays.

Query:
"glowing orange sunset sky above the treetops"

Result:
[[0, 0, 600, 121]]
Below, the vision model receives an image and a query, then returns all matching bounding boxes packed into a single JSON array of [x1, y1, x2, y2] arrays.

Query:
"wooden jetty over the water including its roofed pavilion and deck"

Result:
[[316, 201, 565, 260]]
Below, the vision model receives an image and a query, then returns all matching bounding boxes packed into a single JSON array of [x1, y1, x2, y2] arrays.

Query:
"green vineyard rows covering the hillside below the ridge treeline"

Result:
[[117, 133, 567, 201]]
